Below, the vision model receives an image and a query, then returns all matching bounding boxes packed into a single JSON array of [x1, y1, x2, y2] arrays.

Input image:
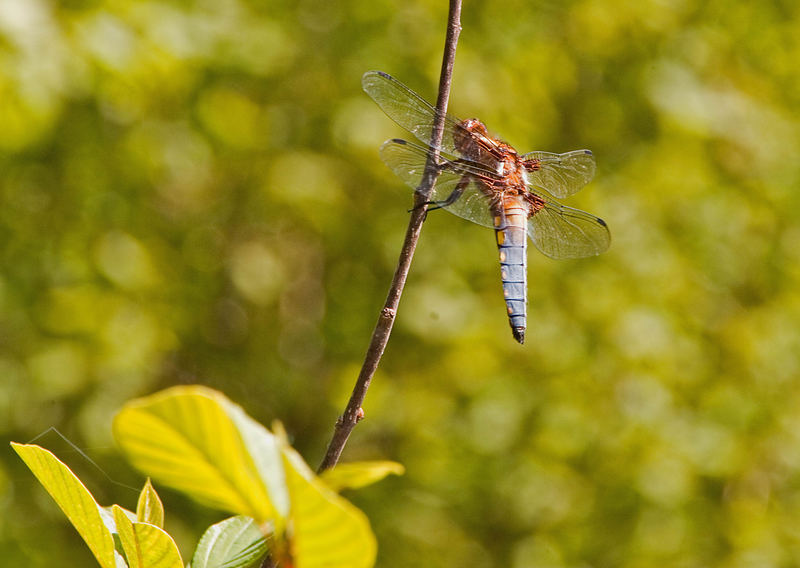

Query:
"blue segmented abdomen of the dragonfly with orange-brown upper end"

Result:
[[494, 197, 528, 343]]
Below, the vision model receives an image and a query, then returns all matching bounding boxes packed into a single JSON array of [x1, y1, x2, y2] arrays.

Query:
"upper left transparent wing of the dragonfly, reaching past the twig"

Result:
[[361, 71, 469, 155]]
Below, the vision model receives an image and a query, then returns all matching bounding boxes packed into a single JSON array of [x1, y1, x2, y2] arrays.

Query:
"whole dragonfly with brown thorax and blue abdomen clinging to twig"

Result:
[[361, 71, 611, 343]]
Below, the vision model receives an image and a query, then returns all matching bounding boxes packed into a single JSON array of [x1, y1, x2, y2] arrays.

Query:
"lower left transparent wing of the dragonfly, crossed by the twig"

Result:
[[380, 139, 494, 228]]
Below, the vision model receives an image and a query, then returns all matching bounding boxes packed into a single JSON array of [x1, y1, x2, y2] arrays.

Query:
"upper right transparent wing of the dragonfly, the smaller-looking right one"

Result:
[[522, 150, 596, 197]]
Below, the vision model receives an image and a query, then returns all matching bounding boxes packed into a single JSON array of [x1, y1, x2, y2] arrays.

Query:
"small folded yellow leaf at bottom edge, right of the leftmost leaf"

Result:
[[112, 505, 183, 568]]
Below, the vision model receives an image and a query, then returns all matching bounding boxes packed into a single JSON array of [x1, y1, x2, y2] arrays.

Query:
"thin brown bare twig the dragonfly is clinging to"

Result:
[[318, 0, 461, 472]]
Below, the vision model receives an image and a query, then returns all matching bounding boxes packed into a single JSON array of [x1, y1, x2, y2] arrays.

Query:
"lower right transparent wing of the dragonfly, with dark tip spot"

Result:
[[528, 201, 611, 258]]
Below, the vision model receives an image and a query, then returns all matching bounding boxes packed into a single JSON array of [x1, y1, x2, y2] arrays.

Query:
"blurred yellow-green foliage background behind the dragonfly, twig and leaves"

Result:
[[0, 0, 800, 568]]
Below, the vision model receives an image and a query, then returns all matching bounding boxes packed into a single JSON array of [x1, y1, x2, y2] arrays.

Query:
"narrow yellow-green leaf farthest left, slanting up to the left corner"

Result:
[[11, 442, 117, 568]]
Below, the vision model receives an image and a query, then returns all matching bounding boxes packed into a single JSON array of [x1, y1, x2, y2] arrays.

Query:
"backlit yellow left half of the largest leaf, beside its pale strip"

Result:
[[113, 386, 276, 522]]
